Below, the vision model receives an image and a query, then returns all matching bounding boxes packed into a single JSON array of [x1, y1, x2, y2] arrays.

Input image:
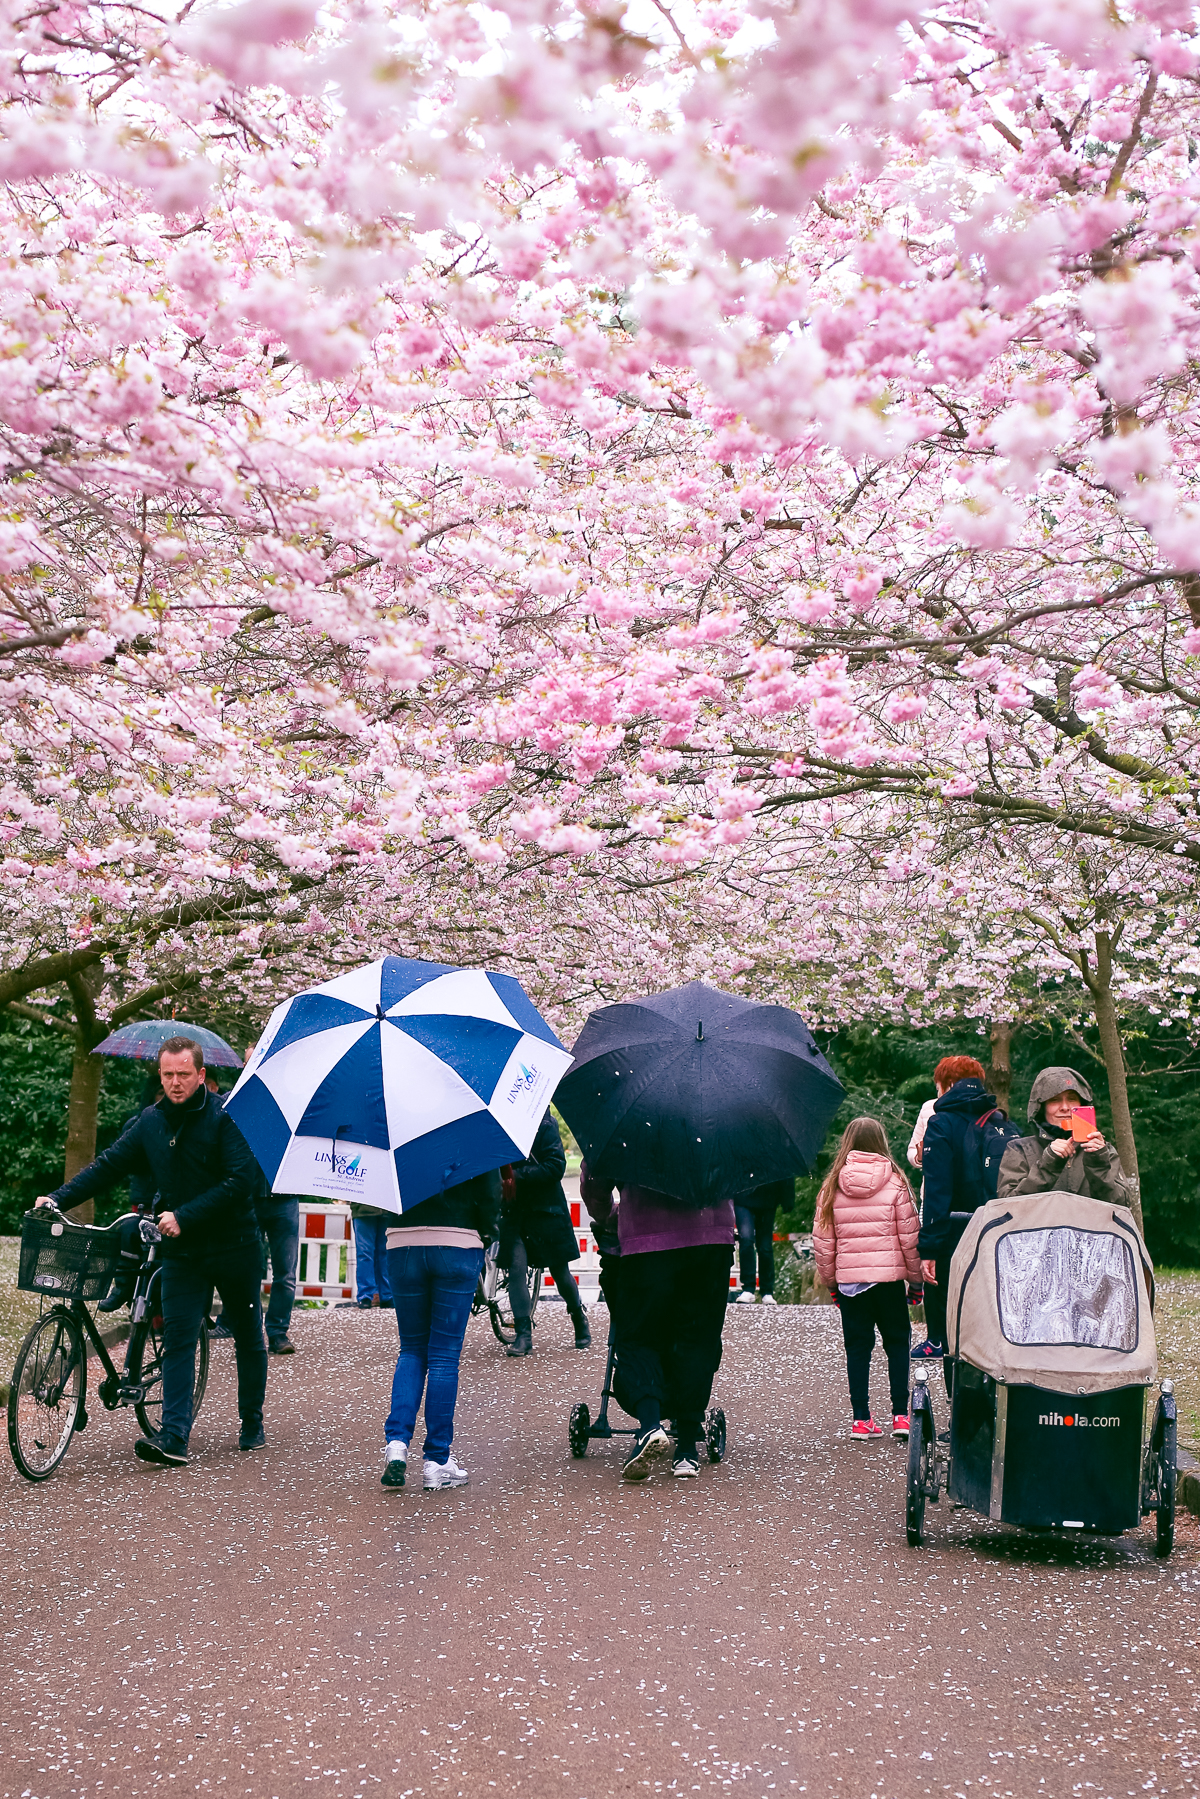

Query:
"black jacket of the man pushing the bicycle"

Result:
[[50, 1087, 257, 1256]]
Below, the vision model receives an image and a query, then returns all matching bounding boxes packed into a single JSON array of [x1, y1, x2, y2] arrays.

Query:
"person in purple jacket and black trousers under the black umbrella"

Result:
[[579, 1162, 736, 1481]]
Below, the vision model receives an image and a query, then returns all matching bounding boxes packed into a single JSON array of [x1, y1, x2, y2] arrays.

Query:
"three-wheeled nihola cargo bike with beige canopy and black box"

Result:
[[907, 1191, 1175, 1556]]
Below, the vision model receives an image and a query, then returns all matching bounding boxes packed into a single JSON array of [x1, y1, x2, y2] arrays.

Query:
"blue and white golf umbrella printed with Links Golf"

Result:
[[225, 955, 570, 1213]]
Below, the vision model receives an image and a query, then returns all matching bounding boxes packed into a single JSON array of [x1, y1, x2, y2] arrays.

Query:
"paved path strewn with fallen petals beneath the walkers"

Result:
[[0, 1308, 1200, 1799]]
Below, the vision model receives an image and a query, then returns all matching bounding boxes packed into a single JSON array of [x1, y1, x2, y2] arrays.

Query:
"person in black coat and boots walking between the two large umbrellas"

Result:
[[500, 1112, 592, 1356]]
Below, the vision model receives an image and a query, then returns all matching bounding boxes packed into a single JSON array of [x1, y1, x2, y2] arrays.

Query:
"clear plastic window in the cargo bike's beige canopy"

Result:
[[997, 1225, 1137, 1353]]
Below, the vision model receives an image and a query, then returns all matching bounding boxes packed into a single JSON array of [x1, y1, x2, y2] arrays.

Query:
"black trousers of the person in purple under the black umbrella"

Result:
[[617, 1243, 734, 1445]]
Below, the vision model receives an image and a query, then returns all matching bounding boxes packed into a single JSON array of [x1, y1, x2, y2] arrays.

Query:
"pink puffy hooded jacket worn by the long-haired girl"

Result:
[[813, 1150, 921, 1286]]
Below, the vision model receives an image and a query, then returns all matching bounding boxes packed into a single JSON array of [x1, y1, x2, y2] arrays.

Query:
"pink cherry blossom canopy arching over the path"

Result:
[[0, 0, 1200, 1194]]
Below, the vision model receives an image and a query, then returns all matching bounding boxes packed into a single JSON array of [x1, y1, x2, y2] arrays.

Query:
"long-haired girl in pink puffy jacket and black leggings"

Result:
[[813, 1119, 921, 1443]]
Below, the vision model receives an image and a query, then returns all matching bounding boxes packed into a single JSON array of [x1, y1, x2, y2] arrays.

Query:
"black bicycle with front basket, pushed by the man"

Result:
[[9, 1205, 209, 1481]]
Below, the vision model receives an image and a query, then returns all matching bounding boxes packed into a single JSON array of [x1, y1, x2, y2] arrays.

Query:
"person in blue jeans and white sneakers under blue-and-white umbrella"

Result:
[[383, 1169, 500, 1490]]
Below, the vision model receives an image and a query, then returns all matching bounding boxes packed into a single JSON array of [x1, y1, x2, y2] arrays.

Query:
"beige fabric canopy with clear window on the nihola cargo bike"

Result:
[[946, 1191, 1159, 1392]]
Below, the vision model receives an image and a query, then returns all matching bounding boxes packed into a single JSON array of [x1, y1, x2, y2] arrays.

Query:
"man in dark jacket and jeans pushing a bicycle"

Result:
[[38, 1036, 266, 1468]]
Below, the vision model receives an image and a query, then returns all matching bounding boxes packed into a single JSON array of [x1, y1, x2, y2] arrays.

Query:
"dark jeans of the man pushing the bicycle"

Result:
[[162, 1243, 266, 1443]]
